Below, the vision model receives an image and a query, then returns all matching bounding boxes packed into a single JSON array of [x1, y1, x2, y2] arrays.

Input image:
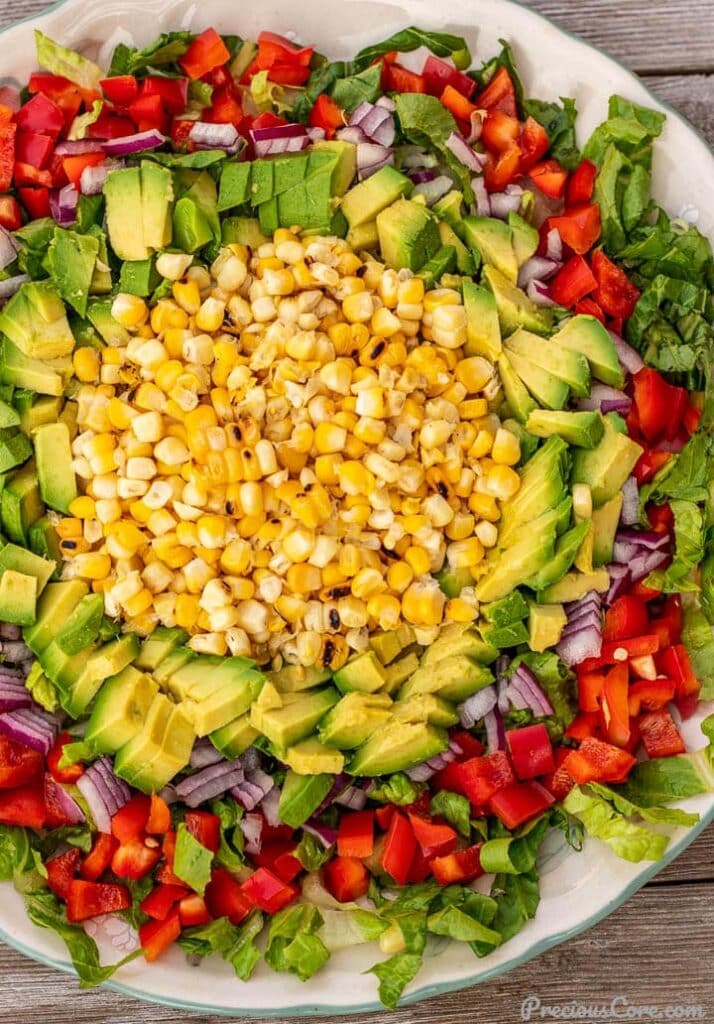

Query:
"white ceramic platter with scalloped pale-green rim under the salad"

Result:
[[0, 0, 714, 1018]]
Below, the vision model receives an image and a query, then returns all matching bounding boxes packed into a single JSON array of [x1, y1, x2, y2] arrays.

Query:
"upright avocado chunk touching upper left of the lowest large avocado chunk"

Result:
[[84, 666, 159, 754]]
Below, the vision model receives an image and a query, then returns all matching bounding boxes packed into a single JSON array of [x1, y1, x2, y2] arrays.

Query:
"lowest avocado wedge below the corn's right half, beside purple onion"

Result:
[[347, 721, 449, 776]]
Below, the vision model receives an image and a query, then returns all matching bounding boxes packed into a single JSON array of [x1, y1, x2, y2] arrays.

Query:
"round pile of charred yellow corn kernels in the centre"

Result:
[[58, 230, 520, 668]]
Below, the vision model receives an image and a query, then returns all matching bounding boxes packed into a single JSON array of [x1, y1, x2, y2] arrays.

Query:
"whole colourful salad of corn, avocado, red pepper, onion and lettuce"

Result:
[[0, 22, 714, 1008]]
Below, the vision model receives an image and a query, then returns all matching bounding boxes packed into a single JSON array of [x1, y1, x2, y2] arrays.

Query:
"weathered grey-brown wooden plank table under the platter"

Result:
[[0, 0, 714, 1024]]
